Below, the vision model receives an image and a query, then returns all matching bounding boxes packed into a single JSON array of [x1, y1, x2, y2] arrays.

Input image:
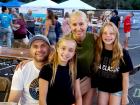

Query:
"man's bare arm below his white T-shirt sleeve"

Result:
[[8, 90, 22, 103]]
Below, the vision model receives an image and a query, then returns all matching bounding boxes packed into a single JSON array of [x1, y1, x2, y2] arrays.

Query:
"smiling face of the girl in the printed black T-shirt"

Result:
[[102, 25, 116, 48]]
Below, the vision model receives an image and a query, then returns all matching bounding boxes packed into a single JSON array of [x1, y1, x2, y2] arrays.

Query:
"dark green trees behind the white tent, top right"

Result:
[[82, 0, 140, 10]]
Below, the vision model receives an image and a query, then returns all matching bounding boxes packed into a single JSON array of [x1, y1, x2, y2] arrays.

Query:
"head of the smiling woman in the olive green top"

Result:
[[70, 11, 88, 41]]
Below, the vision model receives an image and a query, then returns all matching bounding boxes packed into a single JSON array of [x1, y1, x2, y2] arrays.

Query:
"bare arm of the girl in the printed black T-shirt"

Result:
[[122, 72, 129, 105]]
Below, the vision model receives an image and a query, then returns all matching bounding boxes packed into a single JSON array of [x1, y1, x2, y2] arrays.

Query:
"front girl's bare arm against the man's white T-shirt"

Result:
[[39, 78, 49, 105]]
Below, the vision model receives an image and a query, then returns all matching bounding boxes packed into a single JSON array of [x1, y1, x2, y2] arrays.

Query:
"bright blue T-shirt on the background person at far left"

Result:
[[0, 13, 12, 28]]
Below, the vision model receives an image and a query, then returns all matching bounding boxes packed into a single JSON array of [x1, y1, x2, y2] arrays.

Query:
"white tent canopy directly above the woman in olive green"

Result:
[[55, 0, 96, 10]]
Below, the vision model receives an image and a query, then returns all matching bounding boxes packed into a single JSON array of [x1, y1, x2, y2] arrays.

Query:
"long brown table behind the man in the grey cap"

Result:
[[0, 47, 31, 60]]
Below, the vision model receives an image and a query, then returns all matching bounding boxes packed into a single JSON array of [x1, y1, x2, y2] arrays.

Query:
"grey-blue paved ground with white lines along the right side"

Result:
[[120, 29, 140, 105]]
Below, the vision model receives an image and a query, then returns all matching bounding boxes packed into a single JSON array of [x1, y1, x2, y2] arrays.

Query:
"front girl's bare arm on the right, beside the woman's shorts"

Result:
[[74, 79, 82, 105]]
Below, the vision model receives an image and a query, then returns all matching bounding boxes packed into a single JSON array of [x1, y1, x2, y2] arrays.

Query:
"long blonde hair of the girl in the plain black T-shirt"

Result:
[[50, 35, 77, 86]]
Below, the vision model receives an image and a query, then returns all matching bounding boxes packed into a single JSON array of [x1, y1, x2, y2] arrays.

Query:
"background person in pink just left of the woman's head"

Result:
[[62, 12, 71, 35]]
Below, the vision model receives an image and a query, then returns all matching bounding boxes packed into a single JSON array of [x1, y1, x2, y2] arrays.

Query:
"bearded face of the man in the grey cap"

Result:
[[30, 40, 50, 62]]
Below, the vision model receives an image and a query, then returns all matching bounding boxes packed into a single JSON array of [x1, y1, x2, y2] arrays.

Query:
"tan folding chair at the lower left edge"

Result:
[[0, 77, 11, 102]]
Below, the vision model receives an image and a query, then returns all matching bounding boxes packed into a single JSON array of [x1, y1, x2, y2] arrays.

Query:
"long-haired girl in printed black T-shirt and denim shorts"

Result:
[[94, 22, 133, 105]]
